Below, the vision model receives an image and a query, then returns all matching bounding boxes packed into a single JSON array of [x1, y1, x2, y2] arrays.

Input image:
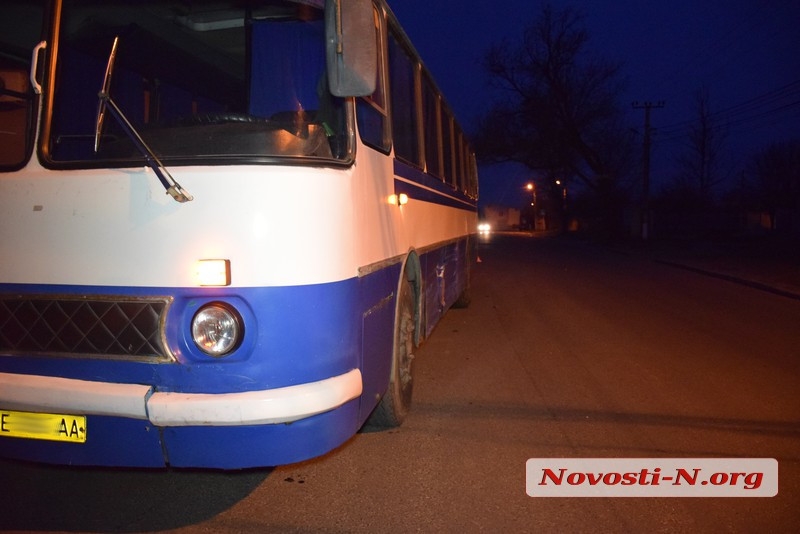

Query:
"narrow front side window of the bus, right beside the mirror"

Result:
[[356, 5, 392, 153]]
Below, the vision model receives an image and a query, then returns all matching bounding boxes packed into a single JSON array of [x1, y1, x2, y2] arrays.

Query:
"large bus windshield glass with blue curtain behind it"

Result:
[[47, 0, 349, 166]]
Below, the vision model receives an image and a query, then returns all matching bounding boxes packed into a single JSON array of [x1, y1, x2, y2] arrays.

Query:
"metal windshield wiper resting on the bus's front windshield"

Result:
[[94, 36, 194, 202]]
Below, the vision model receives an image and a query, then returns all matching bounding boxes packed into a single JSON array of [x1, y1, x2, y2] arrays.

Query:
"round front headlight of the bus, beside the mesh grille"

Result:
[[192, 302, 244, 357]]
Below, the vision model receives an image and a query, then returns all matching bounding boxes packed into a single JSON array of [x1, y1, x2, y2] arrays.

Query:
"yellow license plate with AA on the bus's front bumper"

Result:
[[0, 409, 86, 443]]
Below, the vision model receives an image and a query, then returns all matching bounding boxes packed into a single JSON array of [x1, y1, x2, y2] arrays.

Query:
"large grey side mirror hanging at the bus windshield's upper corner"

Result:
[[325, 0, 378, 97]]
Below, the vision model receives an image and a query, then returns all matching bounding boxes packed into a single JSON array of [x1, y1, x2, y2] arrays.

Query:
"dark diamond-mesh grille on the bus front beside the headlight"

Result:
[[0, 295, 172, 361]]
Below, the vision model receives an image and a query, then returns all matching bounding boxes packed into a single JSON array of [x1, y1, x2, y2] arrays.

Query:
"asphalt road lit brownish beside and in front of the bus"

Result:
[[0, 236, 800, 533]]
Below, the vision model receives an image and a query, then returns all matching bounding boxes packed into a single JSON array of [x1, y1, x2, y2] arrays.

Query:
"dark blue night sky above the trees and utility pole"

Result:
[[389, 0, 800, 205]]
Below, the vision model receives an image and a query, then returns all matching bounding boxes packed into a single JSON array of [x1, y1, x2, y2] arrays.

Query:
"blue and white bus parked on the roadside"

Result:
[[0, 0, 477, 469]]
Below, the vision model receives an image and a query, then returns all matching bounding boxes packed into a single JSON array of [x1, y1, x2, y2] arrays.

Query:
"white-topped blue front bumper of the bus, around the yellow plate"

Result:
[[0, 369, 363, 469]]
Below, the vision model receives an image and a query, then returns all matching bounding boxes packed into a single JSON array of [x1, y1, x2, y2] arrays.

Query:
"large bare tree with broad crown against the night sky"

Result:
[[477, 5, 630, 190]]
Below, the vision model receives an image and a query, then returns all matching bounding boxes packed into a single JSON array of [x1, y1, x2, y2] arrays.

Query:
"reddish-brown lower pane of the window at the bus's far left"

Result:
[[0, 68, 32, 168]]
